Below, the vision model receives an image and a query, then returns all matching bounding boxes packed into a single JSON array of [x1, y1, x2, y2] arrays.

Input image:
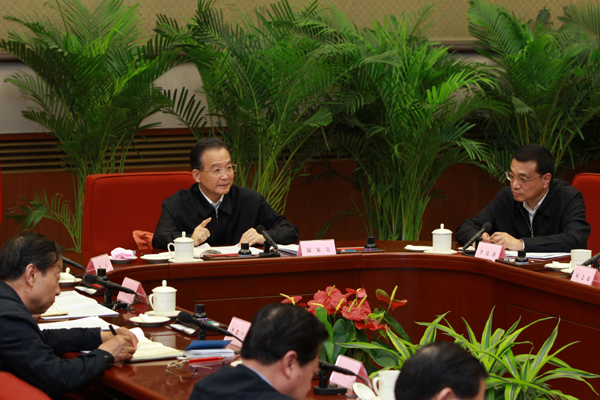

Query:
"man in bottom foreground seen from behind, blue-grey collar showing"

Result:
[[190, 303, 329, 400]]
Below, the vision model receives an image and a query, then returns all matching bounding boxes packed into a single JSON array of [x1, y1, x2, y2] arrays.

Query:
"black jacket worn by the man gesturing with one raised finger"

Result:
[[152, 183, 298, 249]]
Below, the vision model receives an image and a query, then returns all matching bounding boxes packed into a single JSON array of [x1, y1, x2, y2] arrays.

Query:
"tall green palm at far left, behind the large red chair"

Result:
[[0, 0, 181, 251]]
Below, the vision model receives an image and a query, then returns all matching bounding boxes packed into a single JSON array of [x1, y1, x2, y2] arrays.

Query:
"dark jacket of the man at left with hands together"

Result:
[[0, 281, 113, 397]]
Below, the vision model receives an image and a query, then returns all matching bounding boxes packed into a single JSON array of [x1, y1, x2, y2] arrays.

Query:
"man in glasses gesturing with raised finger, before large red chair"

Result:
[[152, 138, 298, 249]]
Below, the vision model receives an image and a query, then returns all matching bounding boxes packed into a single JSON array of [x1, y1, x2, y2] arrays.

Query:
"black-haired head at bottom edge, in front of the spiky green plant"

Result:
[[396, 342, 488, 400]]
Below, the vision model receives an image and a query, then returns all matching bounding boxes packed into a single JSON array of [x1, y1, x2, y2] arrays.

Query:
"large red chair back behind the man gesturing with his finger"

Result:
[[82, 172, 195, 256]]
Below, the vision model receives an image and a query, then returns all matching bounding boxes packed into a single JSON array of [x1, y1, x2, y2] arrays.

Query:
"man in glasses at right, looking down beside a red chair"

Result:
[[455, 144, 590, 252]]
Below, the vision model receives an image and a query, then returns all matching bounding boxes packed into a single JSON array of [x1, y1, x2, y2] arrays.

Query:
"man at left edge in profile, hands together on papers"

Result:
[[0, 232, 137, 397]]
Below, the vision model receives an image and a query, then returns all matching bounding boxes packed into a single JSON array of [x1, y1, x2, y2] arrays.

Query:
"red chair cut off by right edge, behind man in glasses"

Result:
[[573, 173, 600, 254]]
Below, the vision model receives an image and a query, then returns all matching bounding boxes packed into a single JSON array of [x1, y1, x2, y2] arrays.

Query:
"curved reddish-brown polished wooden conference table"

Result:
[[71, 242, 600, 399]]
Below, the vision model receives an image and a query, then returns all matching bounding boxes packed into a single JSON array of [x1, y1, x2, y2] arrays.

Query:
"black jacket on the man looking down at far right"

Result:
[[455, 179, 590, 252]]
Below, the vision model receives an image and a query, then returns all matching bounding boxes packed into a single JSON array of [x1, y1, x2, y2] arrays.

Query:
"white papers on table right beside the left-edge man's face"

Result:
[[42, 291, 119, 321]]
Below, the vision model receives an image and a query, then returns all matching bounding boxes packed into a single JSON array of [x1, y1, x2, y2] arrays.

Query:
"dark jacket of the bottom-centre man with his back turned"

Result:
[[190, 365, 293, 400]]
